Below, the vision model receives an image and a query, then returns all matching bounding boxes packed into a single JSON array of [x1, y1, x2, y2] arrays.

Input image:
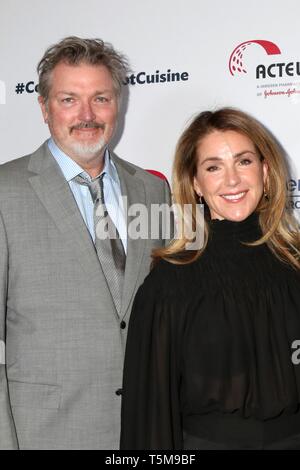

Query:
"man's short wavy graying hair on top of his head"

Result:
[[37, 36, 130, 101]]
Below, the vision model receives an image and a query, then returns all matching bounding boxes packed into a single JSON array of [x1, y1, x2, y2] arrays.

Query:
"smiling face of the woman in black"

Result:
[[194, 131, 268, 222]]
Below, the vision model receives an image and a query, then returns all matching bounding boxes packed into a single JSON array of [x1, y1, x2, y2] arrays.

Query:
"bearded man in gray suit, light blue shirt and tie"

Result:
[[0, 37, 170, 449]]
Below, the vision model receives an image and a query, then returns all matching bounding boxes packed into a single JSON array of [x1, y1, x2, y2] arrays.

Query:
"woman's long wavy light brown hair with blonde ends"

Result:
[[152, 108, 300, 269]]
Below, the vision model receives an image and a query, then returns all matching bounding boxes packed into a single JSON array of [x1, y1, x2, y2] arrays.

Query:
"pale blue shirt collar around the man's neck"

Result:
[[48, 137, 120, 184]]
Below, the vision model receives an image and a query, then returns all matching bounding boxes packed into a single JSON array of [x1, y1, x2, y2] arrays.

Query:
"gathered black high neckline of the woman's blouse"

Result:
[[209, 212, 262, 242]]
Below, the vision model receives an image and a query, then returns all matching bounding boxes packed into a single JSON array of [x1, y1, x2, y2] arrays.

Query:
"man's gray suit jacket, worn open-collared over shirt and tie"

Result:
[[0, 144, 170, 449]]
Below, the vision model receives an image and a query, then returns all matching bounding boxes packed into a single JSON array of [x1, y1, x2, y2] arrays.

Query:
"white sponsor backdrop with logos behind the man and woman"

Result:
[[0, 0, 300, 215]]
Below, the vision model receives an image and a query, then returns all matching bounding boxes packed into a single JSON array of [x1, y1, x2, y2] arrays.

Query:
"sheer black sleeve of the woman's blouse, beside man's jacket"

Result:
[[121, 266, 182, 450]]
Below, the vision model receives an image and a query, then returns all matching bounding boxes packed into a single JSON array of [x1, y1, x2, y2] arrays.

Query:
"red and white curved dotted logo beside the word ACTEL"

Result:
[[229, 39, 281, 75]]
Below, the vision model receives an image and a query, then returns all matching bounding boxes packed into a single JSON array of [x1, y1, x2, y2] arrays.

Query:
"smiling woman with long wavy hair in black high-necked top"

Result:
[[121, 108, 300, 450]]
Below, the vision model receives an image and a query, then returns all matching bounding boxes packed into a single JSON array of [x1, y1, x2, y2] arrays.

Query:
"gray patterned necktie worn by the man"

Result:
[[74, 173, 126, 314]]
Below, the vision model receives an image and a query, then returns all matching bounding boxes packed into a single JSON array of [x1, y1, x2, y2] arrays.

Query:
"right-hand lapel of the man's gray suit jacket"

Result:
[[111, 154, 146, 317]]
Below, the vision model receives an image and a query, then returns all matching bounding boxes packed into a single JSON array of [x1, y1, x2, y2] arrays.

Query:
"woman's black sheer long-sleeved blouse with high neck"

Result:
[[121, 214, 300, 449]]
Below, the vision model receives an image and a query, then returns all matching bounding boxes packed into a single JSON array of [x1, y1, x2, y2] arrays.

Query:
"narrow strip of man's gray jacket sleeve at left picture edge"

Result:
[[0, 214, 18, 450]]
